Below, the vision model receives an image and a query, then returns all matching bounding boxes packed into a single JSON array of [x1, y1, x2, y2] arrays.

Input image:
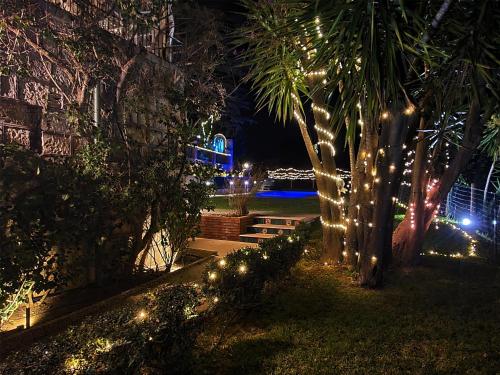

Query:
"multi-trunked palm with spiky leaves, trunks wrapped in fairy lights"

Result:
[[240, 0, 498, 286]]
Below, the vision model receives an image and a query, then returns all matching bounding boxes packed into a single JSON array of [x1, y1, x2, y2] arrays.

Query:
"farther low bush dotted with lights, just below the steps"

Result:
[[203, 228, 307, 309]]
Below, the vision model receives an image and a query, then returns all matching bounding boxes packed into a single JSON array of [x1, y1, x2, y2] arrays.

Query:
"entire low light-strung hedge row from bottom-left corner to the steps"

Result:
[[0, 235, 307, 374]]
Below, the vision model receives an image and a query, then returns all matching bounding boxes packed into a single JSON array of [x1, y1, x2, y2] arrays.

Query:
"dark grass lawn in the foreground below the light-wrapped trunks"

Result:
[[196, 223, 500, 374]]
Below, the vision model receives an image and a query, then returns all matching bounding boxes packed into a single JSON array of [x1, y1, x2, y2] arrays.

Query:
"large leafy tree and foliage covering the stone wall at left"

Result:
[[0, 1, 225, 318]]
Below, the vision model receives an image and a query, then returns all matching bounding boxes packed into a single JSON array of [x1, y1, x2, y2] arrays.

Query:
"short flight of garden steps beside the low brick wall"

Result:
[[240, 216, 316, 243]]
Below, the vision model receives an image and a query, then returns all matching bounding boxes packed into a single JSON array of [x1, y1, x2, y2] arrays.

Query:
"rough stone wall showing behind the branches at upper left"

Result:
[[0, 0, 182, 157]]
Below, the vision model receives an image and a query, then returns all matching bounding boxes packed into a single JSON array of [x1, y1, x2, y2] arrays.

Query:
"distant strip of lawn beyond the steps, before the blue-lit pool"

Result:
[[212, 197, 319, 215]]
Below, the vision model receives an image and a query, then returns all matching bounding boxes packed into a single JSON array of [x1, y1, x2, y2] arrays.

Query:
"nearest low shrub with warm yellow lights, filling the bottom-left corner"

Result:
[[0, 285, 201, 374]]
